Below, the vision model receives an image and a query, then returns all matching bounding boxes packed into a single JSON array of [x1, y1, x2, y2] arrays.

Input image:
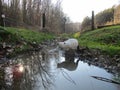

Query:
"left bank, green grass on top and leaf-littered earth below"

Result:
[[0, 27, 55, 57]]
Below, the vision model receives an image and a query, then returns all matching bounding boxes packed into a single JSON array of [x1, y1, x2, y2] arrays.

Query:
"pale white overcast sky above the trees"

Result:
[[62, 0, 120, 22]]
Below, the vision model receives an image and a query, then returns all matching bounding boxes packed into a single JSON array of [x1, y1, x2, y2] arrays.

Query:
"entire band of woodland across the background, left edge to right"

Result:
[[0, 0, 120, 34]]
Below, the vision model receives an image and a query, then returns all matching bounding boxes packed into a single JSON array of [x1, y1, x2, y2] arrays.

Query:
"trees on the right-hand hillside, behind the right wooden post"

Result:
[[81, 5, 120, 31]]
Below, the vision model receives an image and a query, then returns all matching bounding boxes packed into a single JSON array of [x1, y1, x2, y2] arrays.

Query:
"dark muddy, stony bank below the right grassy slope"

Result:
[[77, 47, 120, 74]]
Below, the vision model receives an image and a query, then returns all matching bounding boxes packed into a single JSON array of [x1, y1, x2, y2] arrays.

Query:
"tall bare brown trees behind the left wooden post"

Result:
[[0, 0, 65, 33]]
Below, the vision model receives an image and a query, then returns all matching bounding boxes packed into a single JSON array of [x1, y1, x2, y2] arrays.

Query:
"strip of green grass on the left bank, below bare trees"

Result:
[[6, 27, 54, 43]]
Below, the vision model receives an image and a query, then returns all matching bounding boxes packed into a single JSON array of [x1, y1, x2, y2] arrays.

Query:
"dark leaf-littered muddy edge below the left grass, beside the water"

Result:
[[0, 39, 57, 60]]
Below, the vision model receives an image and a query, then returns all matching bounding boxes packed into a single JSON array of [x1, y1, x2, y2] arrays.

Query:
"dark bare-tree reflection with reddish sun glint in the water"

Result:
[[0, 50, 58, 90]]
